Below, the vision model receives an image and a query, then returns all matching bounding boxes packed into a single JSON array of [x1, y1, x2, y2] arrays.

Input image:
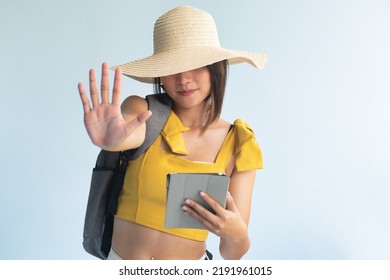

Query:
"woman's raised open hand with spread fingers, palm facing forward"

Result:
[[78, 63, 151, 151]]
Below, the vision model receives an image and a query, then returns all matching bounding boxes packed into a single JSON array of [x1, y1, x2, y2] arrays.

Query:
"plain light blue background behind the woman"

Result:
[[0, 0, 390, 259]]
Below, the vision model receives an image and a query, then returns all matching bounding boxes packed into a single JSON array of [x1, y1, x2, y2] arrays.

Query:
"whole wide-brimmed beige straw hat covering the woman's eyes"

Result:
[[112, 6, 267, 83]]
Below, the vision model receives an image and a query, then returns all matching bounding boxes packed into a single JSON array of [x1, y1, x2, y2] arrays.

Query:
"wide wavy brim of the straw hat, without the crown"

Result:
[[112, 47, 267, 83]]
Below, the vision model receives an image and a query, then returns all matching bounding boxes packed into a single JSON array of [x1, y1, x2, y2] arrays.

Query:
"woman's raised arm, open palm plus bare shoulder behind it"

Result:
[[78, 63, 151, 151]]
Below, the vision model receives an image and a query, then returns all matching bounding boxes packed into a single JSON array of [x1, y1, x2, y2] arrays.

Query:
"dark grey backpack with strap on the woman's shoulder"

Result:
[[83, 94, 171, 259]]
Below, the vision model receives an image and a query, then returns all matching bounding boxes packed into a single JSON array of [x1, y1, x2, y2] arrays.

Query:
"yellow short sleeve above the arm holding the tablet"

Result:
[[234, 119, 263, 172]]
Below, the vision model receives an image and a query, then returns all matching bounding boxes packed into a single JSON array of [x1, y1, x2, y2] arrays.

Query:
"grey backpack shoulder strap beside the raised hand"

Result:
[[124, 93, 172, 160]]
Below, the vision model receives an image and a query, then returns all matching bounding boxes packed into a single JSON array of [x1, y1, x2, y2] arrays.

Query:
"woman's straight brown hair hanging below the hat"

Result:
[[154, 60, 228, 132]]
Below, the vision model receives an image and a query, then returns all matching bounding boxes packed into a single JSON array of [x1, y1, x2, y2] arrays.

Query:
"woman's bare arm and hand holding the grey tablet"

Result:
[[183, 167, 256, 259]]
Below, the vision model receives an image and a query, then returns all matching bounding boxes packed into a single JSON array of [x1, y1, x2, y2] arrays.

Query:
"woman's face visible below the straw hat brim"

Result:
[[161, 67, 211, 109]]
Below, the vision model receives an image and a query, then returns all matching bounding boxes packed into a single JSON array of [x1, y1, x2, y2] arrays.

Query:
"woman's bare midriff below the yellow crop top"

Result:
[[112, 217, 206, 260]]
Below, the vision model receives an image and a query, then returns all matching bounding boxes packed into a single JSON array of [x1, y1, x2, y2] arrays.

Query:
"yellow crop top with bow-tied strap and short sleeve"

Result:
[[116, 111, 263, 241]]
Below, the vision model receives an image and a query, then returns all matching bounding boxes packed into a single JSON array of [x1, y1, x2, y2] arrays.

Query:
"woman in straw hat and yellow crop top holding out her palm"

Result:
[[79, 6, 266, 259]]
